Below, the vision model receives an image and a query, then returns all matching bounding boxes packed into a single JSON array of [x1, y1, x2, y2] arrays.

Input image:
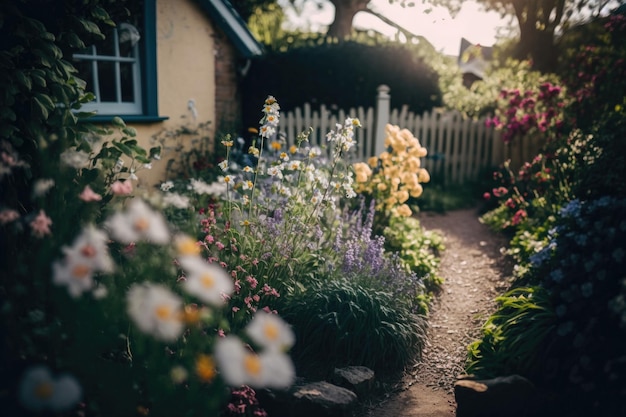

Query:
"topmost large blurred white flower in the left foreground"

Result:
[[106, 199, 170, 244]]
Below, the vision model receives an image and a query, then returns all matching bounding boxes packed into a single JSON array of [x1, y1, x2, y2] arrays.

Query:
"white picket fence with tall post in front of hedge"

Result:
[[280, 86, 537, 184]]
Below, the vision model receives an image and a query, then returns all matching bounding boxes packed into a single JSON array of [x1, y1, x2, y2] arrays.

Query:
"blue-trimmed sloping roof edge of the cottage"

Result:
[[197, 0, 263, 58]]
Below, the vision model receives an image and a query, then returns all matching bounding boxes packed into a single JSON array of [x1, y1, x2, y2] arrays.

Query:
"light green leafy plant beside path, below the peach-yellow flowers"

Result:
[[383, 217, 445, 293]]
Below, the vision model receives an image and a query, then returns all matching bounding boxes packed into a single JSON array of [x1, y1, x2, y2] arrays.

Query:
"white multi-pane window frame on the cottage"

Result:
[[73, 28, 143, 116]]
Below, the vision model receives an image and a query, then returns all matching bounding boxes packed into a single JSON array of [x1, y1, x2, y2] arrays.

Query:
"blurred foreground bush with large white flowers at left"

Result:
[[0, 104, 295, 416]]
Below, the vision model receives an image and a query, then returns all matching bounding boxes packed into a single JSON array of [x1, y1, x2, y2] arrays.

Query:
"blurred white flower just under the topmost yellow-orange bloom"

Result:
[[179, 256, 235, 306]]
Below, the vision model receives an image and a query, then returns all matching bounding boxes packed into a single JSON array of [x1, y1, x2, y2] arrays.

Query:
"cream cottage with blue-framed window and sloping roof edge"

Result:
[[73, 0, 263, 185]]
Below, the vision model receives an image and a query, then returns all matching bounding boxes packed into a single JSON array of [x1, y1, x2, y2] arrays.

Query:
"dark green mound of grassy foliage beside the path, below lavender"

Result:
[[279, 279, 426, 375]]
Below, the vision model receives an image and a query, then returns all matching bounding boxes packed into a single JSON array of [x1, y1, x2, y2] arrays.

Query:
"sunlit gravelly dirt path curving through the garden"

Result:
[[360, 209, 510, 417]]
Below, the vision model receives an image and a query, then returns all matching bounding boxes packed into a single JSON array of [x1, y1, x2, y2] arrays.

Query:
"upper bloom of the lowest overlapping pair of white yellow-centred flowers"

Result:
[[246, 311, 295, 352]]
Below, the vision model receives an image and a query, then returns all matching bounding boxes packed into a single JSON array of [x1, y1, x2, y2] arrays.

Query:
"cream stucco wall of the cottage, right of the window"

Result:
[[132, 0, 216, 187]]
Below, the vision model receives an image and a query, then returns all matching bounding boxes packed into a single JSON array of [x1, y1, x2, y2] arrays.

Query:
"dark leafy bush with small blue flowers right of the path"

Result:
[[470, 196, 626, 415]]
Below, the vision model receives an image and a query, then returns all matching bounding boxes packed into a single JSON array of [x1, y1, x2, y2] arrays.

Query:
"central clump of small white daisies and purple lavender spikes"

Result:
[[155, 96, 434, 380]]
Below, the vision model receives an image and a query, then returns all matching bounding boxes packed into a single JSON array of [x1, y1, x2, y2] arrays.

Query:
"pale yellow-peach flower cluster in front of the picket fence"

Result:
[[354, 125, 430, 223]]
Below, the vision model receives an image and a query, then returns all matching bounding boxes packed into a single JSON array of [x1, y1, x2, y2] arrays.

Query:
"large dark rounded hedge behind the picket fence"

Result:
[[242, 41, 441, 126]]
